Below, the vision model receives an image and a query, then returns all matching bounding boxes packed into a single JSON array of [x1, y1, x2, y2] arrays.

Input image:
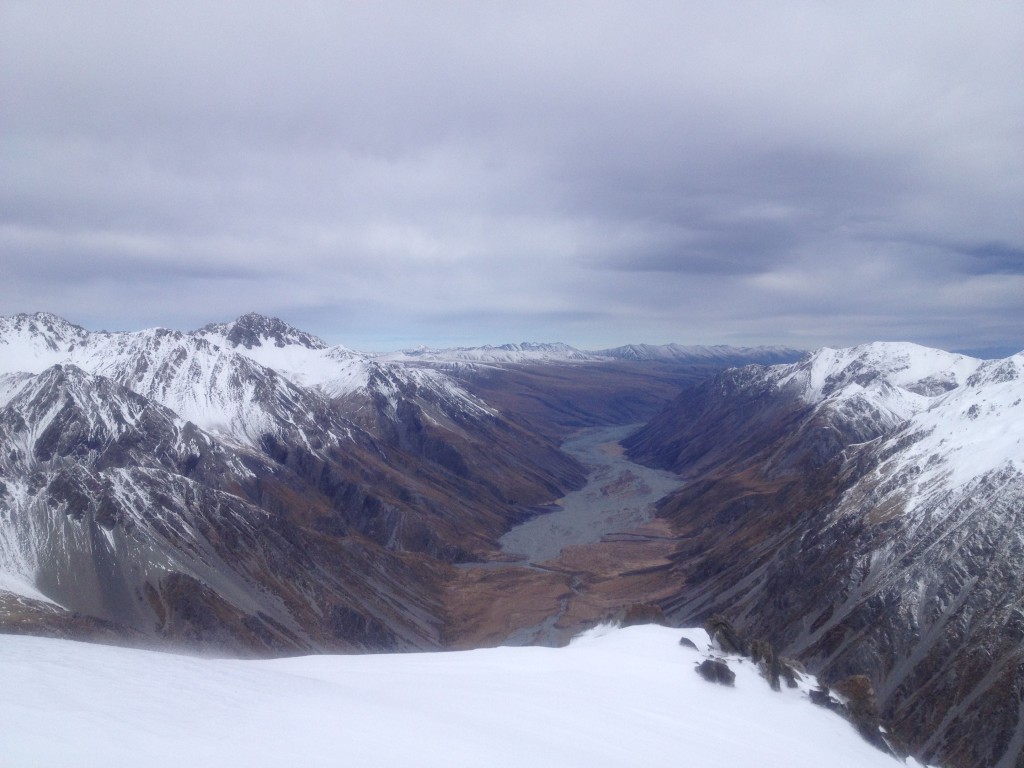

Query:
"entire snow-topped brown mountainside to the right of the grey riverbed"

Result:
[[628, 344, 1024, 767]]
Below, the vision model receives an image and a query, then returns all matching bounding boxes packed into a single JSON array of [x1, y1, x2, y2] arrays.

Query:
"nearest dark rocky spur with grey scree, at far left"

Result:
[[0, 365, 448, 651]]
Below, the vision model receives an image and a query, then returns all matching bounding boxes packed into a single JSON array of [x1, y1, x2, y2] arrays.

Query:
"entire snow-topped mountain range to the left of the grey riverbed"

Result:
[[0, 314, 584, 652]]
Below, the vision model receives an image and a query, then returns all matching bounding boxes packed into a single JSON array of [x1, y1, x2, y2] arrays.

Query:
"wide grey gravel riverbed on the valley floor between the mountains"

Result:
[[500, 424, 683, 563]]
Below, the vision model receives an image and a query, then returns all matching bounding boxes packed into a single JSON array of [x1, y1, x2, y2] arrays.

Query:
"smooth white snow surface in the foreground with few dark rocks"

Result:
[[0, 627, 913, 768]]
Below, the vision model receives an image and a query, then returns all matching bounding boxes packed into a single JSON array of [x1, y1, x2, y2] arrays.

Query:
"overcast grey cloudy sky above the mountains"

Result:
[[0, 0, 1024, 351]]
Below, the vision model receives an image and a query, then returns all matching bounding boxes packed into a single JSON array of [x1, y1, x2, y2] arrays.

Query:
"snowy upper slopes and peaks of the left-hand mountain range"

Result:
[[0, 313, 494, 450]]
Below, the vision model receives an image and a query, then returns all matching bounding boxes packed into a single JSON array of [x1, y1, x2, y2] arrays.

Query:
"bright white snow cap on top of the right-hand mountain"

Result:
[[767, 342, 1024, 499]]
